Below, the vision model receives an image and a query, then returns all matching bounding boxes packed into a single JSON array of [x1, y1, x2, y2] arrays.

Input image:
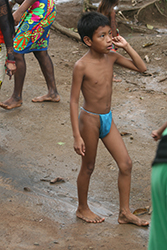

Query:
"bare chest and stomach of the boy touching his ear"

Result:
[[78, 52, 115, 114]]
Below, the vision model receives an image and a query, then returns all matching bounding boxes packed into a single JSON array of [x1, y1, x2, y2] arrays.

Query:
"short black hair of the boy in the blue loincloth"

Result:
[[77, 11, 110, 43]]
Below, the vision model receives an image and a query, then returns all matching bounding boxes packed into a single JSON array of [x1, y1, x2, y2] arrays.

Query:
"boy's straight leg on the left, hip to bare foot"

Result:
[[76, 111, 104, 223]]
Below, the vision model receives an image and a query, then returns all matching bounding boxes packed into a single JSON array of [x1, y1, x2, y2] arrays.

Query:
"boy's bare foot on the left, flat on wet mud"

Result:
[[76, 209, 105, 223]]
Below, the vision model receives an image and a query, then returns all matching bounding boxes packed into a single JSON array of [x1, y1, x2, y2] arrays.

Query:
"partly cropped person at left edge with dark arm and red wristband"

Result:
[[0, 0, 16, 87]]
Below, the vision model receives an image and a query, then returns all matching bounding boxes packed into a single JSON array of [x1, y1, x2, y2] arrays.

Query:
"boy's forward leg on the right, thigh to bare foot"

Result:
[[102, 121, 149, 226]]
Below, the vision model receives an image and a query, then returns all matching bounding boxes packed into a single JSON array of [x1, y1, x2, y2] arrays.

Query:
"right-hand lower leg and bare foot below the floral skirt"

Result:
[[32, 50, 60, 102]]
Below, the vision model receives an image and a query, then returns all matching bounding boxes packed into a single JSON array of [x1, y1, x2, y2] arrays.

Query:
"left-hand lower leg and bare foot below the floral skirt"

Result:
[[0, 53, 26, 109]]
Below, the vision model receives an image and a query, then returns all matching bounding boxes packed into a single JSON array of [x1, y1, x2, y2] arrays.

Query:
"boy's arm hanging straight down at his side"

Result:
[[70, 62, 85, 156]]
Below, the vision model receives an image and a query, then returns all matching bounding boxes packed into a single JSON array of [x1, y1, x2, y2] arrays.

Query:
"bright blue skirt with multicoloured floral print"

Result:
[[14, 0, 56, 54]]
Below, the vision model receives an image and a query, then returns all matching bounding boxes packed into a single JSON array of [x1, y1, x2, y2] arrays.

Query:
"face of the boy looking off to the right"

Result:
[[89, 26, 112, 54]]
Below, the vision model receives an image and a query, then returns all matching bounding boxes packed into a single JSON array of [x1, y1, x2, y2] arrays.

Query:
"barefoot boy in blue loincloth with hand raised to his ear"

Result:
[[70, 12, 149, 226]]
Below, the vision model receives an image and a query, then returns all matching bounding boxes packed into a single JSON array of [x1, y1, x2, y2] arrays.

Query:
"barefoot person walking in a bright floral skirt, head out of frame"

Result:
[[0, 0, 60, 109]]
